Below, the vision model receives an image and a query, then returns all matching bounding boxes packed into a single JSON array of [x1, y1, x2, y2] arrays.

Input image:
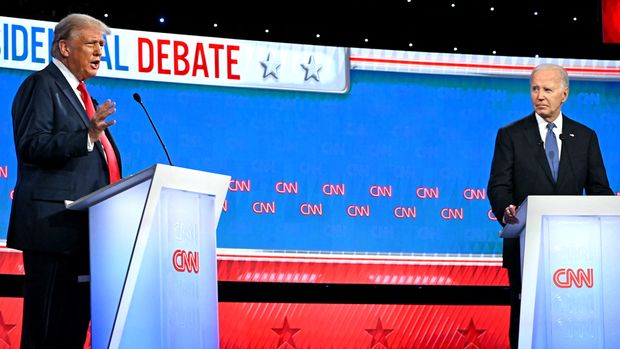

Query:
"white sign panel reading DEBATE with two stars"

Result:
[[0, 17, 349, 93]]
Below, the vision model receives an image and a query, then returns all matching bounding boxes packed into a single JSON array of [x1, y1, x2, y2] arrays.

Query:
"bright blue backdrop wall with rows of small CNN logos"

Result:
[[0, 69, 620, 255]]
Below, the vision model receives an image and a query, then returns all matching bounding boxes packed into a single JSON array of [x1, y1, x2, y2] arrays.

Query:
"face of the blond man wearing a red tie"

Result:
[[59, 27, 105, 81]]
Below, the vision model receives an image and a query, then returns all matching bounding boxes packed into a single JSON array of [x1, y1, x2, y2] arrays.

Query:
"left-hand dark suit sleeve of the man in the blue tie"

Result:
[[487, 128, 517, 225]]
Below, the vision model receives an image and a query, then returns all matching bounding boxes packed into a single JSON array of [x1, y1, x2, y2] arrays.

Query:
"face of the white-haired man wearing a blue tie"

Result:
[[530, 69, 568, 122]]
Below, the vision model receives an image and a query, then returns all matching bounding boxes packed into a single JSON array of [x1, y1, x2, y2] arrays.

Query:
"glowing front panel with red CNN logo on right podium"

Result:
[[534, 216, 604, 348]]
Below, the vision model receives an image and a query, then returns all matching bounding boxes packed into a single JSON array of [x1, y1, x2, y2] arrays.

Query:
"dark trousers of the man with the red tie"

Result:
[[21, 251, 90, 349]]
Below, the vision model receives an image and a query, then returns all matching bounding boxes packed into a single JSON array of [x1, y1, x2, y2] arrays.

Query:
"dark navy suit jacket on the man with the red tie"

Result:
[[7, 63, 121, 255]]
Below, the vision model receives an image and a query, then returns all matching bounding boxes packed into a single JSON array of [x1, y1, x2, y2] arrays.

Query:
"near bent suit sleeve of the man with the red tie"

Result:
[[12, 75, 88, 164]]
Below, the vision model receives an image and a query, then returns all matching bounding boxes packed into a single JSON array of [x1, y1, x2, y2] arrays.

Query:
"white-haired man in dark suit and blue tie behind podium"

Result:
[[487, 64, 613, 349]]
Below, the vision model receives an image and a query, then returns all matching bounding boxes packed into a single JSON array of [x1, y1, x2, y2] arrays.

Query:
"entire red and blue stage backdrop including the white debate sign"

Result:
[[0, 17, 620, 348]]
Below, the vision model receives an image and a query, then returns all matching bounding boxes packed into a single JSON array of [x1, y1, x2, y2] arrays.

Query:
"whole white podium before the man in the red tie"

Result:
[[67, 164, 230, 349]]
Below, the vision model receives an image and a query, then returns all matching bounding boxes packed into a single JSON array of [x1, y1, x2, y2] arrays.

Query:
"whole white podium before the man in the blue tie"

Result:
[[502, 196, 620, 348]]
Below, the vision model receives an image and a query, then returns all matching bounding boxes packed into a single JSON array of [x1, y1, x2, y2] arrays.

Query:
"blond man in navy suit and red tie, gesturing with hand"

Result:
[[7, 14, 121, 349]]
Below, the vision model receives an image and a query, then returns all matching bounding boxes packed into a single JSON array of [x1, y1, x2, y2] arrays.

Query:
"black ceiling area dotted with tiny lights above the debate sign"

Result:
[[0, 0, 620, 60]]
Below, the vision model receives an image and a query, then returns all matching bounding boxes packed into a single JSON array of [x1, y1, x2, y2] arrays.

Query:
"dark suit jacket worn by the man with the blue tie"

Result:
[[487, 113, 613, 274]]
